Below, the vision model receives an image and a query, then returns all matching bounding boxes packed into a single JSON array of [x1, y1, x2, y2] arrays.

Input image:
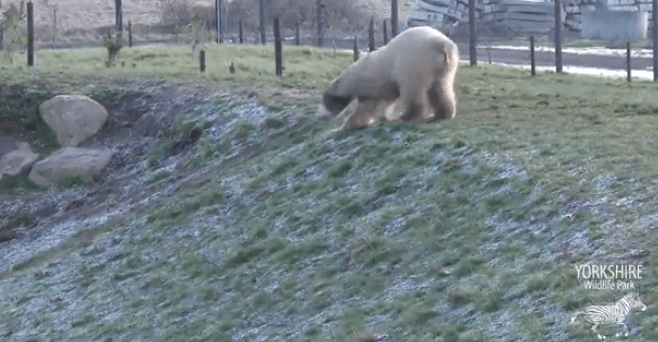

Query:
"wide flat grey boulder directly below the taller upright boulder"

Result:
[[28, 147, 114, 185]]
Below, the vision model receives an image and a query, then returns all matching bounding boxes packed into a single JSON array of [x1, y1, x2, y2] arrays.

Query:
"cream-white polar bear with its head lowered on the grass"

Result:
[[321, 26, 459, 129]]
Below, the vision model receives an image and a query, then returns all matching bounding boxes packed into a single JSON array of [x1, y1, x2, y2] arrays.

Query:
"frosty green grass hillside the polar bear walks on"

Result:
[[0, 47, 658, 341]]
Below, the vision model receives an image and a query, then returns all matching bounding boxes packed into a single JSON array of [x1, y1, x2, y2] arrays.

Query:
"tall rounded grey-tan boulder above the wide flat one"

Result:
[[39, 95, 108, 146]]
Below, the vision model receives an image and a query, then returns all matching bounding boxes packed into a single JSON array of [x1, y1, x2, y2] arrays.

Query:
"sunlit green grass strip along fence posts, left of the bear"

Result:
[[0, 44, 349, 98]]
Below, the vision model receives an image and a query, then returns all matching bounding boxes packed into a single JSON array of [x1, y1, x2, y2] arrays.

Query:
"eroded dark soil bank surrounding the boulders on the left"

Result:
[[0, 81, 294, 272]]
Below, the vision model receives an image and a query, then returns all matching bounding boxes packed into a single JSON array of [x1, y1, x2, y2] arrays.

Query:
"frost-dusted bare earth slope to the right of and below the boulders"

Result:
[[0, 78, 310, 278]]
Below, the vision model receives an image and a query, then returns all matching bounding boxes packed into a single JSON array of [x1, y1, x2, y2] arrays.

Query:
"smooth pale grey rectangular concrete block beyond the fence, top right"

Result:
[[580, 10, 649, 41]]
